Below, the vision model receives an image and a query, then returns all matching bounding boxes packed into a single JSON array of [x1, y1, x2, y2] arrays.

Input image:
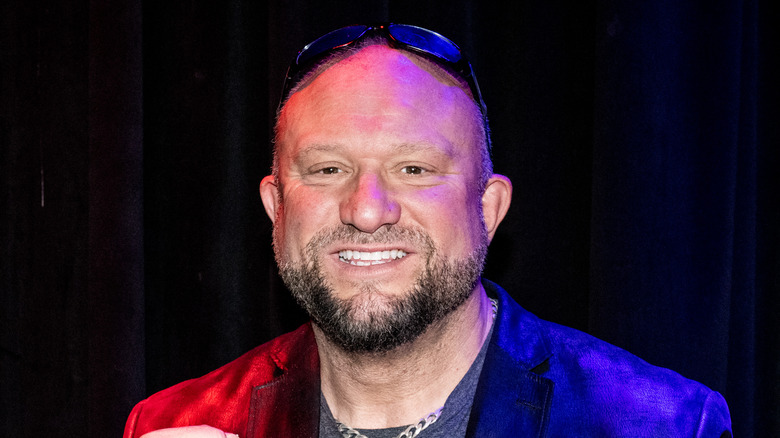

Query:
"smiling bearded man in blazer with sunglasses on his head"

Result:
[[125, 25, 731, 438]]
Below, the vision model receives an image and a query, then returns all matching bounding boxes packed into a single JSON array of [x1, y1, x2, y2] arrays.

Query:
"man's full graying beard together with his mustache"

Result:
[[274, 225, 488, 353]]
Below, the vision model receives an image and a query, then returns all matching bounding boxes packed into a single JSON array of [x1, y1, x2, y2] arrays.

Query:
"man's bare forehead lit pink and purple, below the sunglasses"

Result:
[[277, 45, 481, 156]]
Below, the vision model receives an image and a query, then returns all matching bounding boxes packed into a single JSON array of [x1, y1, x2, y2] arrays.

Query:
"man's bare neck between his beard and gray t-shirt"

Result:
[[314, 283, 493, 429]]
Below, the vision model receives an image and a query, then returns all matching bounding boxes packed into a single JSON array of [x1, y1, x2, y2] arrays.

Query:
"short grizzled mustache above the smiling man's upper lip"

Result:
[[306, 224, 435, 255]]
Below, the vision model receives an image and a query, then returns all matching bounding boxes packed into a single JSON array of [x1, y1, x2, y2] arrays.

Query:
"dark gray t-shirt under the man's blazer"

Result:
[[320, 312, 493, 438]]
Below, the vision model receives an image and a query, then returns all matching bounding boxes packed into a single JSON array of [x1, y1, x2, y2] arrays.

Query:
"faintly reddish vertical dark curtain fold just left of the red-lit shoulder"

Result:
[[87, 0, 146, 436]]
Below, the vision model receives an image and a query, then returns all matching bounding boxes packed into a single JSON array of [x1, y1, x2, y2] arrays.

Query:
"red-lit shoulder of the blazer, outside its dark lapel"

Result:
[[124, 324, 316, 438]]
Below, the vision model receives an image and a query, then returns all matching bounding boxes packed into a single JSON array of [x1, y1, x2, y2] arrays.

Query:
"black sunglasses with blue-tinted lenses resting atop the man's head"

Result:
[[278, 23, 490, 150]]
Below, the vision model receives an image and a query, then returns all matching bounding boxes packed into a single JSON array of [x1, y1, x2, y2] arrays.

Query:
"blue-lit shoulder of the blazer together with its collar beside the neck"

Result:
[[484, 285, 731, 436]]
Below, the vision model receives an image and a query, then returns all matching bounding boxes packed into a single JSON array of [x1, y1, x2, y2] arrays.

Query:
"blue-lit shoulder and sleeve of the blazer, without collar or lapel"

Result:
[[540, 320, 731, 436]]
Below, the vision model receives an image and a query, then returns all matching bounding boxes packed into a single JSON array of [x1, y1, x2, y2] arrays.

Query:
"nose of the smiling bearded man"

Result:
[[339, 173, 401, 233]]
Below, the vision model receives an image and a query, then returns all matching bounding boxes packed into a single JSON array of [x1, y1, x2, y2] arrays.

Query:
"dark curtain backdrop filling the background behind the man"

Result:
[[0, 0, 780, 437]]
